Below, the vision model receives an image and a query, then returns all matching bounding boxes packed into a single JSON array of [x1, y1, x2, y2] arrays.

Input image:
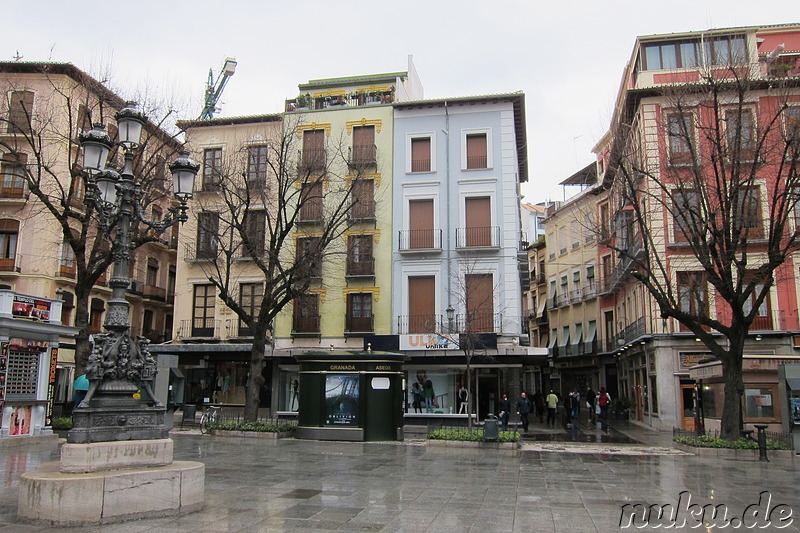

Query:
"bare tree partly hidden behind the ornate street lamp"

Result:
[[0, 63, 180, 373]]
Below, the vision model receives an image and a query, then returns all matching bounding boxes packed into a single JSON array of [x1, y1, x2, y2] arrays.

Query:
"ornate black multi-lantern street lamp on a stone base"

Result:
[[67, 102, 200, 443]]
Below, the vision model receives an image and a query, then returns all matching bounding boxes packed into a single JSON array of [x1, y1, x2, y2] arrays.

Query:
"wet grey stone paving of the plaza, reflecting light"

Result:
[[0, 429, 800, 533]]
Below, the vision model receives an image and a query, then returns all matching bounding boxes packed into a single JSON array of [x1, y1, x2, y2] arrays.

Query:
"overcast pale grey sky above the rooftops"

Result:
[[0, 0, 800, 203]]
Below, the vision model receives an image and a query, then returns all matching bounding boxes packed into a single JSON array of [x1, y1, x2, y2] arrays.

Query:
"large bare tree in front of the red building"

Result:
[[605, 64, 800, 439]]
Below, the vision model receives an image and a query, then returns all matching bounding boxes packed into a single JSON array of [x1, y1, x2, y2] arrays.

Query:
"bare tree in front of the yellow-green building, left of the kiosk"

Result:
[[183, 119, 360, 420]]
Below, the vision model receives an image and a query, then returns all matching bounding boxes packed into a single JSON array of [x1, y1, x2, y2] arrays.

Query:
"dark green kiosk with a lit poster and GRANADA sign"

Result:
[[295, 350, 407, 441]]
